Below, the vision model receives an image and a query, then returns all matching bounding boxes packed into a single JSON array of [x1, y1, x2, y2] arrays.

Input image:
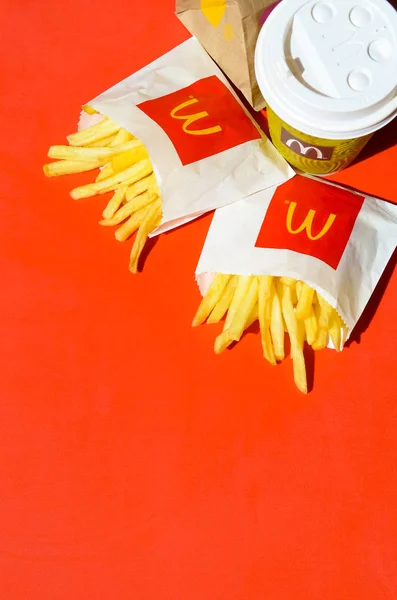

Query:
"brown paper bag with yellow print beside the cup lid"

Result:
[[176, 0, 278, 110]]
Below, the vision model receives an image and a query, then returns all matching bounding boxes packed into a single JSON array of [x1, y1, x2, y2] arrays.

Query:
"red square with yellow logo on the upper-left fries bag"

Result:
[[138, 75, 260, 165]]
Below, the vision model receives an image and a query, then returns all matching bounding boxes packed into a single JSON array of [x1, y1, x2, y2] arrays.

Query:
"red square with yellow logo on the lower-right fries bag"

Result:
[[255, 176, 364, 270]]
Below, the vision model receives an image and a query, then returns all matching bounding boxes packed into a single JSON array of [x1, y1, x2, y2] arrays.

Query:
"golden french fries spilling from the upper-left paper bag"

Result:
[[43, 106, 162, 273]]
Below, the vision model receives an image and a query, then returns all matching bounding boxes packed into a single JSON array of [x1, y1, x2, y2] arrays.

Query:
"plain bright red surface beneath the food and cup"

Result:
[[0, 0, 397, 600]]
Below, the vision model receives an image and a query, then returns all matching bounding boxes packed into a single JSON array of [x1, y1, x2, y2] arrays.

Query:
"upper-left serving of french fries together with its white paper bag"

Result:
[[44, 38, 294, 273]]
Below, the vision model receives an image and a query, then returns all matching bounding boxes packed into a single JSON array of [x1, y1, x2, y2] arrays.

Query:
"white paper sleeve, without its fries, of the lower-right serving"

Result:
[[196, 175, 397, 347]]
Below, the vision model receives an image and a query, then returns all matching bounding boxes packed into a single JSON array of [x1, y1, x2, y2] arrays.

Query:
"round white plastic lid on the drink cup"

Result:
[[255, 0, 397, 139]]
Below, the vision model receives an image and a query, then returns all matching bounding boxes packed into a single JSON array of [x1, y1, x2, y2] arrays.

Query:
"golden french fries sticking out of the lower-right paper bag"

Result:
[[192, 273, 346, 394]]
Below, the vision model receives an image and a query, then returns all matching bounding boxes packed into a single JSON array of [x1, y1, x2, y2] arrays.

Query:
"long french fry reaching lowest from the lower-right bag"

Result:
[[280, 281, 307, 394]]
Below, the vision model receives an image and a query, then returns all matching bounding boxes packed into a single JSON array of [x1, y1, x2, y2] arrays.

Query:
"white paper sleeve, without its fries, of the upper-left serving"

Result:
[[79, 38, 294, 234]]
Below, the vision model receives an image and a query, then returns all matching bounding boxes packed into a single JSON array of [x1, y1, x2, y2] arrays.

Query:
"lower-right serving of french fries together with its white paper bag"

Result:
[[193, 175, 397, 393]]
